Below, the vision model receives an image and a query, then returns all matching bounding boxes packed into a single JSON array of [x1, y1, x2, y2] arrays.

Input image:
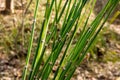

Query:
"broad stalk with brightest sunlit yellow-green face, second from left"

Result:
[[29, 0, 54, 80]]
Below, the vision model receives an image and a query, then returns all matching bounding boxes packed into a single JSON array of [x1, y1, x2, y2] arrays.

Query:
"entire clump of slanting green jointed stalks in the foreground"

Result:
[[22, 0, 120, 80]]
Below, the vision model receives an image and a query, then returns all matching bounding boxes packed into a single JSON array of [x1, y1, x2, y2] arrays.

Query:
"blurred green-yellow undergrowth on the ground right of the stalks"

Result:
[[89, 25, 120, 62]]
